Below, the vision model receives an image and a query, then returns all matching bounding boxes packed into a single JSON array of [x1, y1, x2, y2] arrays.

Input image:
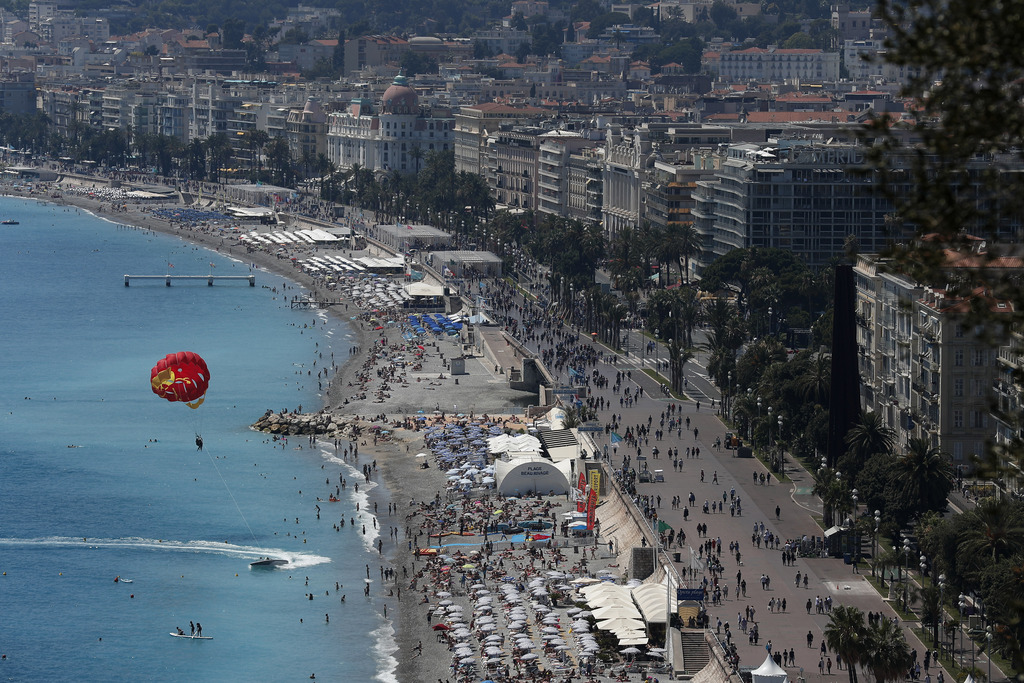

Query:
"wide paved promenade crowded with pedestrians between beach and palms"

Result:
[[483, 274, 1005, 681]]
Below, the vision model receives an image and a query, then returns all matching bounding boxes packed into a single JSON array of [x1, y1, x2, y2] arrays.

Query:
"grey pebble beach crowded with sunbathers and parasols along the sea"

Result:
[[4, 174, 643, 683]]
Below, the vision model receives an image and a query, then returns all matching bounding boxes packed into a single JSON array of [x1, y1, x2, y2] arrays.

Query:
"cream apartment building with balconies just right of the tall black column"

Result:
[[854, 240, 1024, 471]]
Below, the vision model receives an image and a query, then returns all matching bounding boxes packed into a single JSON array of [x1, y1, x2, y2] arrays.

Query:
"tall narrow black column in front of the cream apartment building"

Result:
[[827, 264, 860, 467]]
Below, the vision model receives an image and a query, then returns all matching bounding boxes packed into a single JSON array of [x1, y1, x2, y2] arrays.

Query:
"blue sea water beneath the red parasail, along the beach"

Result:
[[0, 198, 397, 681]]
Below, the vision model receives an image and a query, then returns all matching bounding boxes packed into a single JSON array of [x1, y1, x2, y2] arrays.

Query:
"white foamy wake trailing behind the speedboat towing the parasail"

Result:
[[0, 536, 331, 568]]
